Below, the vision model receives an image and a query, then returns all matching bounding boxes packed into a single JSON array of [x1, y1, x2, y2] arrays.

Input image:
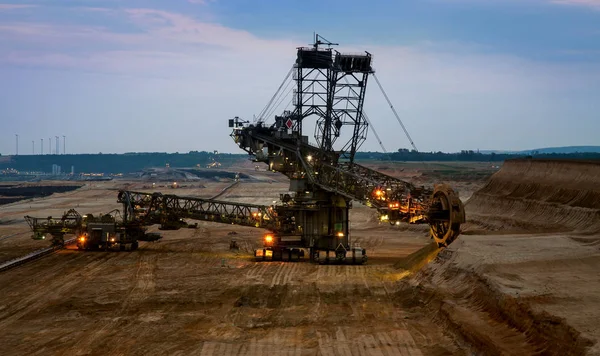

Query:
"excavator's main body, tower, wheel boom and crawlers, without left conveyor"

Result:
[[229, 35, 465, 262]]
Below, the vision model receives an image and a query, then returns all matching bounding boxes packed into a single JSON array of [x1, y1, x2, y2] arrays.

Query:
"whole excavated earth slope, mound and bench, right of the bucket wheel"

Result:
[[412, 159, 600, 356]]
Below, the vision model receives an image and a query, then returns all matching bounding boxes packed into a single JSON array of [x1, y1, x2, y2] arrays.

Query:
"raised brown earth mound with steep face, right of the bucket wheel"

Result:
[[465, 159, 600, 234]]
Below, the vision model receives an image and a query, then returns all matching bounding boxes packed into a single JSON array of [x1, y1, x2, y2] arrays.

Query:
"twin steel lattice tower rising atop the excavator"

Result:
[[291, 35, 374, 162]]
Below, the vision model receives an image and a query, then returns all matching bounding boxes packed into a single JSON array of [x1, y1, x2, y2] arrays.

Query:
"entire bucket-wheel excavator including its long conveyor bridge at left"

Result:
[[24, 35, 465, 264]]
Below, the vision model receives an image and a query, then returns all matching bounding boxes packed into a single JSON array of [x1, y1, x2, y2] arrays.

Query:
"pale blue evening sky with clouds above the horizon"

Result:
[[0, 0, 600, 154]]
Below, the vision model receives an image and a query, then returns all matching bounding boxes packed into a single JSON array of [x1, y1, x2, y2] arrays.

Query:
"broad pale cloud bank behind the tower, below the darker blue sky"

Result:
[[0, 8, 600, 152]]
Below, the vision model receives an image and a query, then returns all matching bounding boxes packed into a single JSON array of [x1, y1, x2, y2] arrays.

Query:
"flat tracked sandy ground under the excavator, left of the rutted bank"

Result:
[[0, 176, 460, 355]]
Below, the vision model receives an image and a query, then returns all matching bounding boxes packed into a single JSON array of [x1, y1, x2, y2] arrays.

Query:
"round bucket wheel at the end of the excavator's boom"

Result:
[[427, 184, 465, 247]]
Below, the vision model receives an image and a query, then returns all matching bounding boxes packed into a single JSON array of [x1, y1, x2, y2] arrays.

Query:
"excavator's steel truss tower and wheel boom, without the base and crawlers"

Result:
[[230, 35, 465, 253]]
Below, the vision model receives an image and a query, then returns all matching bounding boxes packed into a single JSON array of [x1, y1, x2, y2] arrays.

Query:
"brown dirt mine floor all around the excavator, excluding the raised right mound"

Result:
[[0, 160, 600, 356]]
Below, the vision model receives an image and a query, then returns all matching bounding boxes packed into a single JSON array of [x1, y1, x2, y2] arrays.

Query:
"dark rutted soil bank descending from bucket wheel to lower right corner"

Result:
[[415, 250, 594, 356]]
